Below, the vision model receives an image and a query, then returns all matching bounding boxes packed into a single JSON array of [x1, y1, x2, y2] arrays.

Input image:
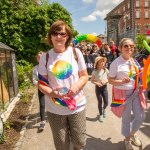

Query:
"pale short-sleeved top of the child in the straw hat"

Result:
[[92, 68, 109, 81]]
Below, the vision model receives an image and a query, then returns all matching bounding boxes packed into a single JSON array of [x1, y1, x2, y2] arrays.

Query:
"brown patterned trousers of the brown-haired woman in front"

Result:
[[47, 110, 86, 150]]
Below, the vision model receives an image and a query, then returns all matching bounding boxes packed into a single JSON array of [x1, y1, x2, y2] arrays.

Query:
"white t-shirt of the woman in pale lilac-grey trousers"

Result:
[[109, 56, 136, 90]]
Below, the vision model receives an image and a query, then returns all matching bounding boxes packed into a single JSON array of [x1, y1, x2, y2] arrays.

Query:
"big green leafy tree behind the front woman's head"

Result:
[[0, 0, 77, 63]]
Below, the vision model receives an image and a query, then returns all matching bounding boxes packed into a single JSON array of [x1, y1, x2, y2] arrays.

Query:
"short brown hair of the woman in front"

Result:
[[48, 20, 72, 48]]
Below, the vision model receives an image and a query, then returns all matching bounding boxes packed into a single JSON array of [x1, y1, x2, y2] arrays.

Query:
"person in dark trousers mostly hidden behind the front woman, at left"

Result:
[[32, 51, 46, 131]]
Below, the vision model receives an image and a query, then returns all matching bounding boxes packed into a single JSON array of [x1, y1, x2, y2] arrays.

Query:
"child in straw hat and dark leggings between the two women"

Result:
[[91, 56, 108, 122]]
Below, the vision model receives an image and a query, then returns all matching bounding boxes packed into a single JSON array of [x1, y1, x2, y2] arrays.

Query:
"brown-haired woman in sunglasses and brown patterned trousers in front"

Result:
[[39, 20, 88, 150]]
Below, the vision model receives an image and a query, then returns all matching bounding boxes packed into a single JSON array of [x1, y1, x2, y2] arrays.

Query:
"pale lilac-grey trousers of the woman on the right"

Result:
[[122, 90, 145, 137]]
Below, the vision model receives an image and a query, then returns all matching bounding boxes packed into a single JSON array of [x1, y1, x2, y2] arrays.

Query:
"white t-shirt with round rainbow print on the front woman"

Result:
[[38, 47, 86, 115]]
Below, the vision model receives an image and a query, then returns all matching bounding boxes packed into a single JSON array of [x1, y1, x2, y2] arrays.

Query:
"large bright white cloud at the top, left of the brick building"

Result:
[[81, 0, 123, 22]]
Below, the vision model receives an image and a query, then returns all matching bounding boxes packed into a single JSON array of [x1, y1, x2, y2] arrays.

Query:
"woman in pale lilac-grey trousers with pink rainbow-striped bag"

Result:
[[108, 38, 145, 150]]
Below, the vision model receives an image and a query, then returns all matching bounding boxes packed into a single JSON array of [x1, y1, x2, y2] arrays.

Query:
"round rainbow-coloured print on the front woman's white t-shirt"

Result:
[[52, 60, 72, 80]]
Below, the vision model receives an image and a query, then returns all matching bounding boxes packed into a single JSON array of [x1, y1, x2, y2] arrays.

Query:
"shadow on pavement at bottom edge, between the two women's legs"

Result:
[[84, 134, 125, 150]]
